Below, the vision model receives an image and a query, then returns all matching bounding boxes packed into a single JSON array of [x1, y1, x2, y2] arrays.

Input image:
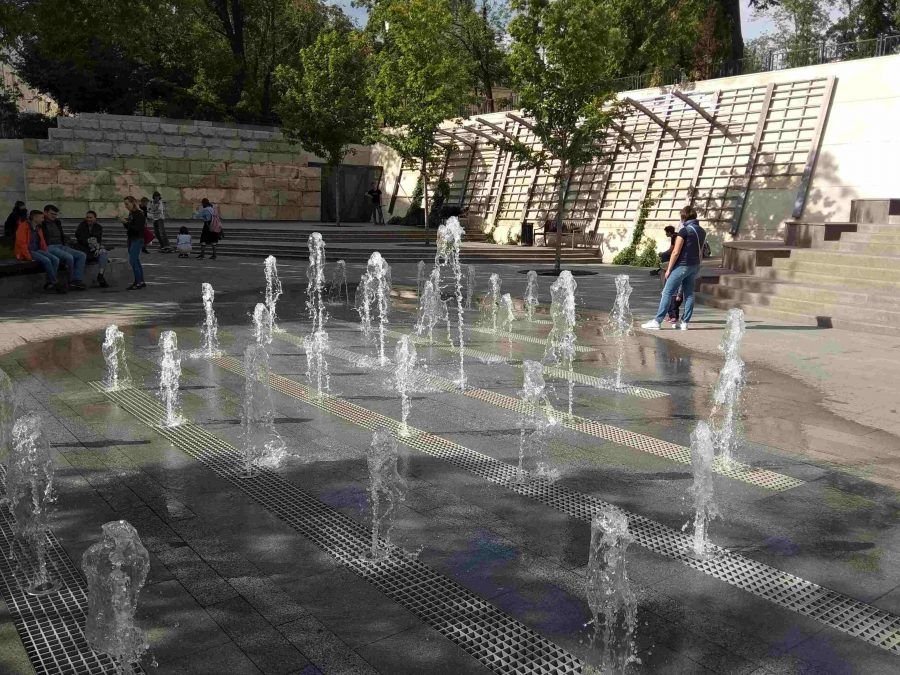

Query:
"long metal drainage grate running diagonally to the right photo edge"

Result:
[[213, 356, 900, 654]]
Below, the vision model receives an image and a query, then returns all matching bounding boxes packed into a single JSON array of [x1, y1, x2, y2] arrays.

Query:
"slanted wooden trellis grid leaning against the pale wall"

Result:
[[392, 78, 834, 256]]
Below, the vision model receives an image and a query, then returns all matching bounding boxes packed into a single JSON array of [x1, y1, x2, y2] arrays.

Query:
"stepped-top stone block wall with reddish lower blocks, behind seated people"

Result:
[[24, 114, 369, 221]]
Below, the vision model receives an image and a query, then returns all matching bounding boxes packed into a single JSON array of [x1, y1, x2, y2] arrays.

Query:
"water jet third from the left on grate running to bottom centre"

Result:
[[239, 345, 286, 478]]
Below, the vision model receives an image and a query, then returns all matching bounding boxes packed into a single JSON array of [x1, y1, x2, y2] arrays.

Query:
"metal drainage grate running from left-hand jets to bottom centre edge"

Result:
[[91, 382, 581, 675]]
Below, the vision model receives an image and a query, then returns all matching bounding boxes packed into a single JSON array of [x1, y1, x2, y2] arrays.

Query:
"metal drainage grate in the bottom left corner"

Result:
[[0, 468, 144, 675]]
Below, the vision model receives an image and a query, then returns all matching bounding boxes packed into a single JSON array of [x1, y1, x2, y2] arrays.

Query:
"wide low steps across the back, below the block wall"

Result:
[[96, 220, 597, 265]]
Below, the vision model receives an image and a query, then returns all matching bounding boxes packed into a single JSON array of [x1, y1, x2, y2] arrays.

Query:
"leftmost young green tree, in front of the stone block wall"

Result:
[[275, 31, 371, 225]]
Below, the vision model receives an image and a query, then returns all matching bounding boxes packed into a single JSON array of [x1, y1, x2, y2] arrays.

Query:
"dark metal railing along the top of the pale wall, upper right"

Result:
[[460, 35, 900, 117]]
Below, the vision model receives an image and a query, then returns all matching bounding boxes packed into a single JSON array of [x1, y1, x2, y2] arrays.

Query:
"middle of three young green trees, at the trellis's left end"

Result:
[[367, 0, 473, 232]]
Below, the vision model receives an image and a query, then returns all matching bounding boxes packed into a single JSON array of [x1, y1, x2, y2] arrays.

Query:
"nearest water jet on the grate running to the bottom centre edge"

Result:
[[366, 429, 406, 560]]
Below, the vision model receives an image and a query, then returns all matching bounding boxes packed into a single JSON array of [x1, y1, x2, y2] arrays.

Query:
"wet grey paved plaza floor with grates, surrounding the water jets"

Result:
[[0, 256, 900, 675]]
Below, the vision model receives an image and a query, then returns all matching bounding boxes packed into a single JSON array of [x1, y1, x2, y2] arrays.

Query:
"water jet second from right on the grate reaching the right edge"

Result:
[[516, 361, 559, 483]]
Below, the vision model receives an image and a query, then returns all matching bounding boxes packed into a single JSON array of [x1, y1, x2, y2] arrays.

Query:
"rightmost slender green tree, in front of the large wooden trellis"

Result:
[[510, 0, 625, 272]]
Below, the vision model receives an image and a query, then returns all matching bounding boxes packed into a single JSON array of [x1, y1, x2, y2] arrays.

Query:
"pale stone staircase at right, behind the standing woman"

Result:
[[698, 199, 900, 334]]
